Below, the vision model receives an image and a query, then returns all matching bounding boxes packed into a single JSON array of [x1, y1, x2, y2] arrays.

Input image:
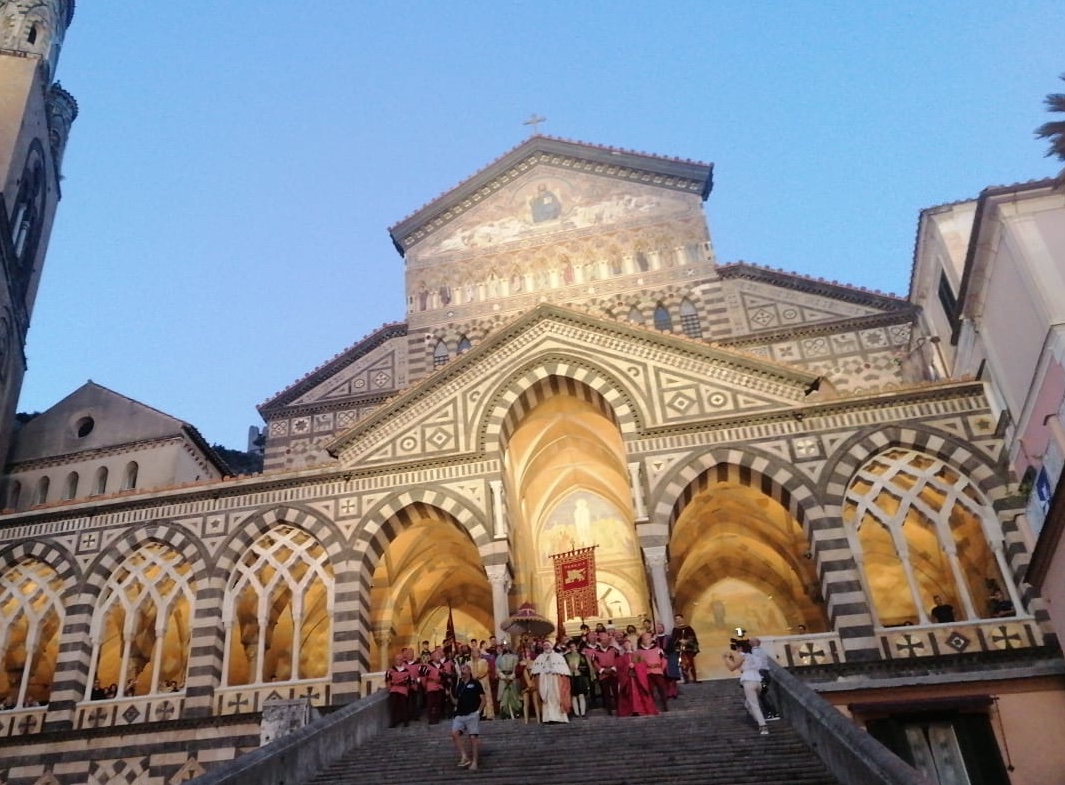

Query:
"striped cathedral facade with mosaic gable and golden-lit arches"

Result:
[[0, 2, 1065, 785]]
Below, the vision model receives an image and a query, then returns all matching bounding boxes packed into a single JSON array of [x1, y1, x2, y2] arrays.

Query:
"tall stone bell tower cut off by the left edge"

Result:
[[0, 0, 78, 459]]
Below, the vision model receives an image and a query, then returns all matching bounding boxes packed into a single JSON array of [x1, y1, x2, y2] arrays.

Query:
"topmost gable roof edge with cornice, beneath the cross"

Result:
[[389, 134, 714, 256]]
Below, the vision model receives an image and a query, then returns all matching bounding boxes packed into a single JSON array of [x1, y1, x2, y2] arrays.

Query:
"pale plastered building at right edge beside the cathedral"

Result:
[[911, 180, 1065, 673]]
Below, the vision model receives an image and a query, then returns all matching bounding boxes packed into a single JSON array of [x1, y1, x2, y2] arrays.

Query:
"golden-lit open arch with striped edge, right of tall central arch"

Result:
[[660, 449, 834, 669]]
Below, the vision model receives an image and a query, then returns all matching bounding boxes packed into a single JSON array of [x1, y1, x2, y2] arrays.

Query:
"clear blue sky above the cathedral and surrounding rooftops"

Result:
[[14, 0, 1065, 448]]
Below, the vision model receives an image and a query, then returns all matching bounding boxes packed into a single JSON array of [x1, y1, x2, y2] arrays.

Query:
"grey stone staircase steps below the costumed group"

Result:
[[311, 680, 839, 785]]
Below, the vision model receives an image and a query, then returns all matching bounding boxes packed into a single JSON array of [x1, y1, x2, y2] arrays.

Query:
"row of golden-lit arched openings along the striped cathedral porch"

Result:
[[0, 440, 1021, 706]]
